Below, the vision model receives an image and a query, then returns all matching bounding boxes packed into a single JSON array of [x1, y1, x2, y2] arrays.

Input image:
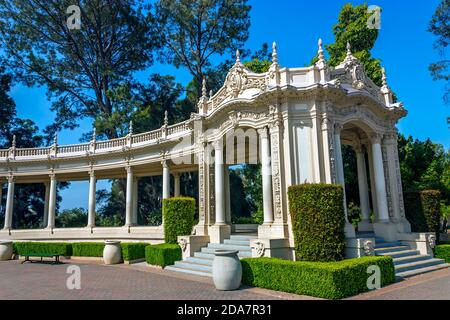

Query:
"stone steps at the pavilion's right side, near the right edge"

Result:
[[375, 238, 449, 278]]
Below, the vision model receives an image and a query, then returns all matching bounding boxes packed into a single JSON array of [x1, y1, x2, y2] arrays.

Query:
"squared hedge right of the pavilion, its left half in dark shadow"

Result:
[[405, 190, 441, 235]]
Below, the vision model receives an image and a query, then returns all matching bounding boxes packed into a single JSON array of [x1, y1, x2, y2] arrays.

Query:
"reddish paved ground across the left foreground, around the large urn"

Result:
[[0, 260, 313, 300]]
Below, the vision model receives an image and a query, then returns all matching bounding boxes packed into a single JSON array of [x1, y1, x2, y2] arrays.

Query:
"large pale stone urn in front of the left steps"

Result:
[[212, 250, 242, 291]]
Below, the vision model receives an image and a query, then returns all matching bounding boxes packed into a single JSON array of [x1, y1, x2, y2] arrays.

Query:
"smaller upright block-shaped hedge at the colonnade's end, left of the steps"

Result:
[[163, 198, 195, 244]]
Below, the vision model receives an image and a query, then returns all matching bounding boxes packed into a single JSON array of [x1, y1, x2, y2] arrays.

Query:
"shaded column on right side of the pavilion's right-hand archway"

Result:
[[372, 134, 389, 222]]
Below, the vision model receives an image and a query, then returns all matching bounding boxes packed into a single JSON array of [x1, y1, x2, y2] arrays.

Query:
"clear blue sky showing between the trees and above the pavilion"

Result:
[[11, 0, 450, 208]]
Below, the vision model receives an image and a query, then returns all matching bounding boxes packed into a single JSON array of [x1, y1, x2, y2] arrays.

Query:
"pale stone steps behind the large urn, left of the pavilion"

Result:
[[165, 235, 257, 277]]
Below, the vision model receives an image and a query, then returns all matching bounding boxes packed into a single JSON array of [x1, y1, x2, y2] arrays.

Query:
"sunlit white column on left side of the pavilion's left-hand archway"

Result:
[[214, 140, 226, 225]]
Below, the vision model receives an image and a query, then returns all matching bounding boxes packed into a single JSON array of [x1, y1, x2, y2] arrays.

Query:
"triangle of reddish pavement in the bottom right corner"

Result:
[[349, 268, 450, 300]]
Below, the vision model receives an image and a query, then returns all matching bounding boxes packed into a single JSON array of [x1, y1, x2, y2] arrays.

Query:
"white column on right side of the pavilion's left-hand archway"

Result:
[[258, 128, 274, 224]]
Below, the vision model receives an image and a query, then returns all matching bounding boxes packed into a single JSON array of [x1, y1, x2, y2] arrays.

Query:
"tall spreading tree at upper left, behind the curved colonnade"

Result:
[[0, 0, 158, 138]]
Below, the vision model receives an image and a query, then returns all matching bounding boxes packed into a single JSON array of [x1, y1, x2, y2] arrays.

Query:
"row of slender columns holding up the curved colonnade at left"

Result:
[[0, 161, 180, 230]]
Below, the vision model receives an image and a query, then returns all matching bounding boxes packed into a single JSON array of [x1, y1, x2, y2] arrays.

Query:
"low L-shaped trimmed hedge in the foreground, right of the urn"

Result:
[[241, 257, 395, 299]]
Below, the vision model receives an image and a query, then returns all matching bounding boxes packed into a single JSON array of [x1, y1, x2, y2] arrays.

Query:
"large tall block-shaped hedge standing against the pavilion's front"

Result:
[[288, 184, 345, 262]]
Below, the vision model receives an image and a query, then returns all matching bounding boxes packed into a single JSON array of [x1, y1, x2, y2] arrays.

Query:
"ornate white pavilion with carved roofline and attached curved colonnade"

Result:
[[0, 41, 436, 259]]
